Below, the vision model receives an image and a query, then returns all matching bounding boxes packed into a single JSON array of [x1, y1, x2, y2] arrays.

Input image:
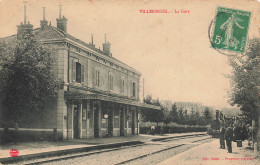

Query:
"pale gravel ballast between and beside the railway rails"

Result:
[[31, 136, 213, 165]]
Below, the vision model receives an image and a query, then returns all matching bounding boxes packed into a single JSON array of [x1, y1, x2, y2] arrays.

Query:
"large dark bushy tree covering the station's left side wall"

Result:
[[0, 33, 61, 124]]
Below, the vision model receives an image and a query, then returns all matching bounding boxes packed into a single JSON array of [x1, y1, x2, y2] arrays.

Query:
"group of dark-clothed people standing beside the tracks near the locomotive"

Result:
[[219, 124, 249, 153]]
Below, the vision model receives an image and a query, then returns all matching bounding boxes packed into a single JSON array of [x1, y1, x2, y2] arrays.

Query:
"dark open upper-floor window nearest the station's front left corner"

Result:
[[72, 60, 85, 83]]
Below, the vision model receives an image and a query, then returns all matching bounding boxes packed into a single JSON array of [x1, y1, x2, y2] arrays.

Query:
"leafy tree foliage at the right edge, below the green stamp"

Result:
[[229, 39, 260, 120]]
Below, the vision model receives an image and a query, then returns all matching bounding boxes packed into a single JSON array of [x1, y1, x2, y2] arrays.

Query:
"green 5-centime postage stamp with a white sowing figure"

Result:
[[212, 7, 251, 53]]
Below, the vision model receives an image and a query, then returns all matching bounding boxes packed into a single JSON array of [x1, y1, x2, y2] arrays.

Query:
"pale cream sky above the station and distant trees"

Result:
[[0, 0, 260, 108]]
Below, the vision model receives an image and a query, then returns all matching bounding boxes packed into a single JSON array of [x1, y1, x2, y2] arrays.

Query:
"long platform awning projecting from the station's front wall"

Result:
[[65, 92, 161, 110]]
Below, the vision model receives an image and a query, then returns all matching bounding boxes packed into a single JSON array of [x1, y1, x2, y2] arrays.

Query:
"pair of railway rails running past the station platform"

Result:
[[7, 135, 211, 165]]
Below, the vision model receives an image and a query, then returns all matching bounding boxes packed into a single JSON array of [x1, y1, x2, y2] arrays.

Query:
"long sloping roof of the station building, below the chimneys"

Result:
[[0, 25, 141, 75]]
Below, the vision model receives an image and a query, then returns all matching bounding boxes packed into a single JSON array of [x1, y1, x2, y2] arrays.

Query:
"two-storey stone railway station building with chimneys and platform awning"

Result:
[[0, 7, 160, 140]]
